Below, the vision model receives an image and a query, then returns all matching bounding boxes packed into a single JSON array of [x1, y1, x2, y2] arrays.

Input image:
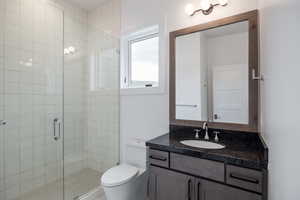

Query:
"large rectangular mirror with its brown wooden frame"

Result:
[[170, 11, 259, 132]]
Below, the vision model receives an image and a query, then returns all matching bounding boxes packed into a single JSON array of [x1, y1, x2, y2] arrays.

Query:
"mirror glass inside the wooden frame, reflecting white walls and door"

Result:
[[176, 21, 249, 124]]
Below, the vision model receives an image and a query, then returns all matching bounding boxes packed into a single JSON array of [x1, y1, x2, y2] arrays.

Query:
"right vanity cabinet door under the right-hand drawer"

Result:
[[195, 179, 262, 200]]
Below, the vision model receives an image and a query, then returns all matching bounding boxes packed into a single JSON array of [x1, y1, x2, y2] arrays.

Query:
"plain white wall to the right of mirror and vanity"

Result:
[[260, 0, 300, 200]]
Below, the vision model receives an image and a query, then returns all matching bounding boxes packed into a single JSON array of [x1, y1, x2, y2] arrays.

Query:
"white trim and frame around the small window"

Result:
[[120, 25, 165, 95]]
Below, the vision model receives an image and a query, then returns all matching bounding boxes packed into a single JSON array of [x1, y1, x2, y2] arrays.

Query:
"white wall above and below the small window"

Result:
[[120, 0, 168, 165]]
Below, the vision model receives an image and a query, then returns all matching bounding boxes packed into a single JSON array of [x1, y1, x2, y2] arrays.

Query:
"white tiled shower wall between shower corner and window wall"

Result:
[[86, 0, 121, 172]]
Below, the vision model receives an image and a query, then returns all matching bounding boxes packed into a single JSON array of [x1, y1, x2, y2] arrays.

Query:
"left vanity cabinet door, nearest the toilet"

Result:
[[149, 166, 195, 200]]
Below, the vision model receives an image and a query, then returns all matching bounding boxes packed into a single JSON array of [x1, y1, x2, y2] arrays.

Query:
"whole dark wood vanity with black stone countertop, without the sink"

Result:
[[147, 128, 268, 200]]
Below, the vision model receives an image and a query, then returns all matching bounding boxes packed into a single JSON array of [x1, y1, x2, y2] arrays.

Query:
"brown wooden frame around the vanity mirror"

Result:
[[169, 10, 260, 132]]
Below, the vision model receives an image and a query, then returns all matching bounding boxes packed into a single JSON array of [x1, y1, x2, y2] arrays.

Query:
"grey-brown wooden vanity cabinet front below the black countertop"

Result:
[[148, 149, 266, 200]]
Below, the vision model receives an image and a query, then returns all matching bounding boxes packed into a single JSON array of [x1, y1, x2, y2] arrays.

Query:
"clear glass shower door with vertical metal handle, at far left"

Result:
[[0, 0, 63, 200]]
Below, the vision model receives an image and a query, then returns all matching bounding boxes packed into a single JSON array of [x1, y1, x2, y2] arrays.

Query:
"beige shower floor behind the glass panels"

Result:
[[16, 169, 106, 200]]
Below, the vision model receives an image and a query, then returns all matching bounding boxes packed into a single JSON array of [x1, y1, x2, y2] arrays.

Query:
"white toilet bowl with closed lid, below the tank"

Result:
[[101, 164, 148, 200]]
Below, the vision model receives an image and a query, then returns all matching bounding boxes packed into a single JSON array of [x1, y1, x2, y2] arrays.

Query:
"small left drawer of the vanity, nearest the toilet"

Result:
[[149, 149, 169, 168]]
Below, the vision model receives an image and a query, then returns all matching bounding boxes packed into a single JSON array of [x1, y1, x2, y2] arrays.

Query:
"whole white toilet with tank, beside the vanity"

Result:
[[101, 139, 148, 200]]
